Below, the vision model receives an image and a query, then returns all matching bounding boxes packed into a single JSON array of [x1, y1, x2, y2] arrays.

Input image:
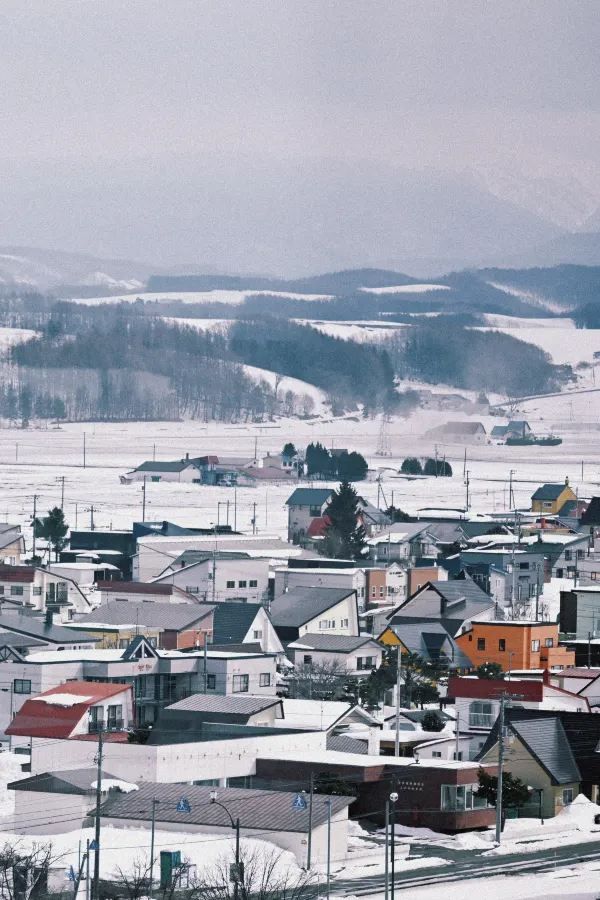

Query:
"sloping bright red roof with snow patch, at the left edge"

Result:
[[5, 681, 131, 738]]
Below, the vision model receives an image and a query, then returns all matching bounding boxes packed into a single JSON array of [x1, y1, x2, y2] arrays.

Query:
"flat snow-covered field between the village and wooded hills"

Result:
[[0, 391, 600, 552]]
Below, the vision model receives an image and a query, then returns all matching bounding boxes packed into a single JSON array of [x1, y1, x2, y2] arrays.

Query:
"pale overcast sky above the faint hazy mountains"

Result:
[[0, 0, 600, 268]]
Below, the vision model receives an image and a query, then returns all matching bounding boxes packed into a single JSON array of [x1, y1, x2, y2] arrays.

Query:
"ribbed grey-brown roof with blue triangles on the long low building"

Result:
[[101, 784, 354, 833]]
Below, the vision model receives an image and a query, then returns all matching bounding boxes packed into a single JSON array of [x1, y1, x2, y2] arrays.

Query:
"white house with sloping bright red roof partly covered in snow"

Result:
[[6, 681, 133, 738]]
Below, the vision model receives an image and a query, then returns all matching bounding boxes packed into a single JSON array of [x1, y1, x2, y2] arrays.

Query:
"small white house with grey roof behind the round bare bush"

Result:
[[286, 633, 383, 678]]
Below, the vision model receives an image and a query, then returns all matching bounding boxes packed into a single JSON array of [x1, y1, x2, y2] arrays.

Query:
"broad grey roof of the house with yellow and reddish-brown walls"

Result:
[[76, 600, 214, 631]]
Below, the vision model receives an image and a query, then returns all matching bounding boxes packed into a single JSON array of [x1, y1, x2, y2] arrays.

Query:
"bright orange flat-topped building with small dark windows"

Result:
[[455, 621, 575, 672]]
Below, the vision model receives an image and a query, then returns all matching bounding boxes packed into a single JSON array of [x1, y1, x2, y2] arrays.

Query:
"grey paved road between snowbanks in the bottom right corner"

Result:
[[332, 840, 600, 896]]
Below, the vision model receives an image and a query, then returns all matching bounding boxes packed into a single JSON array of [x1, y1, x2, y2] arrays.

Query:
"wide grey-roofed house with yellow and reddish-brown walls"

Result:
[[70, 601, 213, 650]]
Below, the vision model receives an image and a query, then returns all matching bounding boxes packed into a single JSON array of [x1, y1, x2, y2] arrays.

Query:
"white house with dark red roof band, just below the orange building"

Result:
[[447, 672, 590, 759]]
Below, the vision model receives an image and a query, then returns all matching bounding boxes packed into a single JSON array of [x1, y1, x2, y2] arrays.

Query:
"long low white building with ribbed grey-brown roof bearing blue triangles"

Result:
[[101, 784, 353, 865]]
